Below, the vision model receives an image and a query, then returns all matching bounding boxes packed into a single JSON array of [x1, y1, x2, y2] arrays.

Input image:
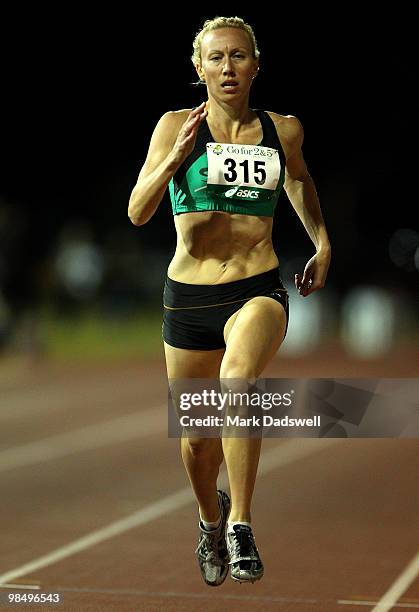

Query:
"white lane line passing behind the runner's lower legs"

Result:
[[0, 438, 340, 585]]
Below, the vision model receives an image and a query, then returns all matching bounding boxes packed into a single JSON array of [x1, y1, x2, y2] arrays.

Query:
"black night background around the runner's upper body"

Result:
[[0, 6, 419, 354]]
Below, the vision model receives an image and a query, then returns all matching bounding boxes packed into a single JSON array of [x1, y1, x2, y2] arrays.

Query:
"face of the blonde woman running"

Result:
[[196, 28, 258, 98]]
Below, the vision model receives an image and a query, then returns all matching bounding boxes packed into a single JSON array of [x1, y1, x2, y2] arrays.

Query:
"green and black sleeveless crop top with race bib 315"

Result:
[[169, 110, 285, 217]]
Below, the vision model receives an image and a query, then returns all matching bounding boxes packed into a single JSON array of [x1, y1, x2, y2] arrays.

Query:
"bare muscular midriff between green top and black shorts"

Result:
[[167, 211, 279, 285]]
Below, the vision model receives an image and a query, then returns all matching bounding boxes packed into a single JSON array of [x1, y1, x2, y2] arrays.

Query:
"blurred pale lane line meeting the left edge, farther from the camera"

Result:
[[0, 406, 167, 472]]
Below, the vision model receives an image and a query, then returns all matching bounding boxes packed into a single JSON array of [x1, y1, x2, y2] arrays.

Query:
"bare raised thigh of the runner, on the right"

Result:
[[221, 296, 287, 378]]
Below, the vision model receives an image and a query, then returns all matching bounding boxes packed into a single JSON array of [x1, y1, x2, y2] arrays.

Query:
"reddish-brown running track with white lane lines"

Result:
[[0, 350, 419, 612]]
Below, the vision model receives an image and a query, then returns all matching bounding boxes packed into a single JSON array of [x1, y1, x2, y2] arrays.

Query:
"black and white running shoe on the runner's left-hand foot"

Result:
[[195, 491, 230, 586]]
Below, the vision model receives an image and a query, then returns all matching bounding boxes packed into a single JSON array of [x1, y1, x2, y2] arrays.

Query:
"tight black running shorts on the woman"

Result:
[[163, 268, 288, 351]]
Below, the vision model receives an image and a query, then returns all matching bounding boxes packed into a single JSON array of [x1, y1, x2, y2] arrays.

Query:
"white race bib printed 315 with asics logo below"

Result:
[[207, 142, 281, 201]]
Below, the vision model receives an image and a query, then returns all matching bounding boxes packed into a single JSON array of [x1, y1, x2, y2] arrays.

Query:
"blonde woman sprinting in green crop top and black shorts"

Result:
[[128, 17, 330, 586]]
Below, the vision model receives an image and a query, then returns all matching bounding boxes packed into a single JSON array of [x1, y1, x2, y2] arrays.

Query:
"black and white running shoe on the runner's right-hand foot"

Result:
[[227, 525, 263, 582]]
